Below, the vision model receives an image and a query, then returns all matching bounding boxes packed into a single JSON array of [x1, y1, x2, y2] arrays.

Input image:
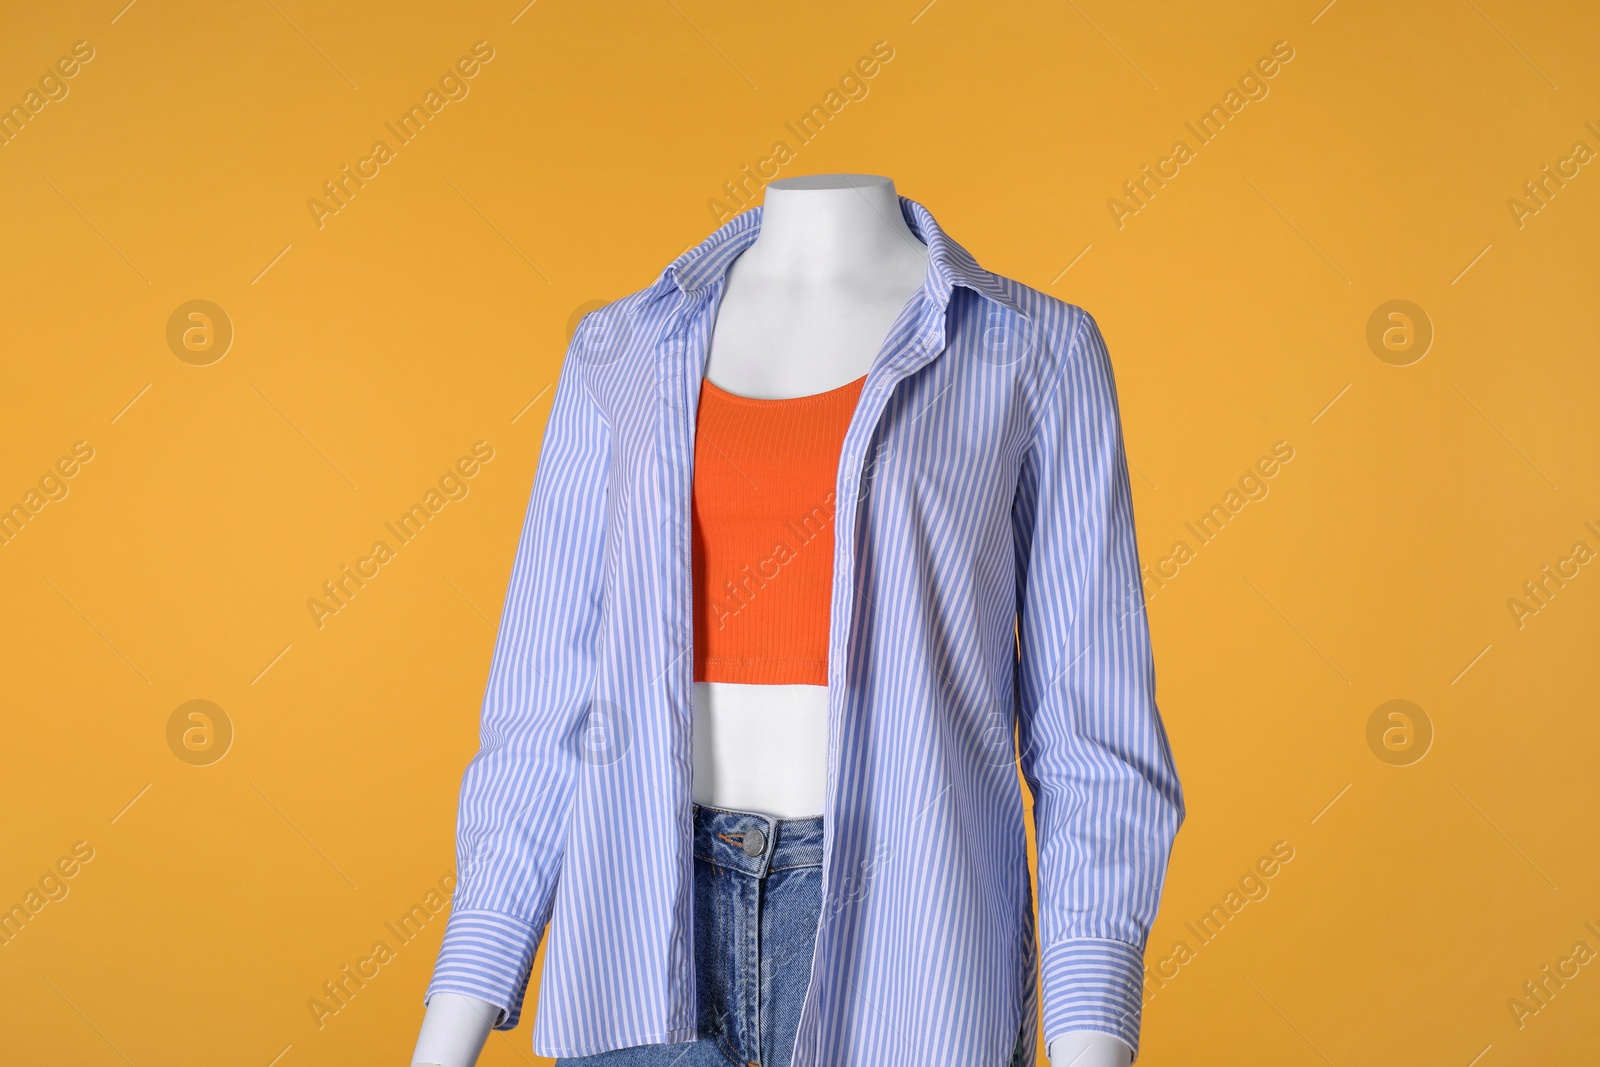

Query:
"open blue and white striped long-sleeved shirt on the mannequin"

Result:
[[427, 197, 1184, 1067]]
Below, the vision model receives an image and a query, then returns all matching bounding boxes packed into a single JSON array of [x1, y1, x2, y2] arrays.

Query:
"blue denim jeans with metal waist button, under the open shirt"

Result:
[[555, 805, 822, 1067]]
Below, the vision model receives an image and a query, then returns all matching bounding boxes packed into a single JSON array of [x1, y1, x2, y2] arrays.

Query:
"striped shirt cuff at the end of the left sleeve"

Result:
[[422, 912, 539, 1030]]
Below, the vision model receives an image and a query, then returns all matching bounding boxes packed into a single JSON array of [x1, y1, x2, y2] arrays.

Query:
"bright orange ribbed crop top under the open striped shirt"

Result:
[[691, 376, 866, 685]]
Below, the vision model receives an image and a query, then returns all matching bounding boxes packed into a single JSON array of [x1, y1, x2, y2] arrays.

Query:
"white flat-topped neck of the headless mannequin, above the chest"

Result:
[[739, 174, 926, 286]]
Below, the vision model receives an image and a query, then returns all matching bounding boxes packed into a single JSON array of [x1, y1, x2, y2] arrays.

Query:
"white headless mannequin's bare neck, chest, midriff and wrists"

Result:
[[411, 174, 1131, 1067]]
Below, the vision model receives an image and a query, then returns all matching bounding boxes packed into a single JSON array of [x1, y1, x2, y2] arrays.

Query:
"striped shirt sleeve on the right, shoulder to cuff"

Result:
[[1014, 309, 1184, 1056]]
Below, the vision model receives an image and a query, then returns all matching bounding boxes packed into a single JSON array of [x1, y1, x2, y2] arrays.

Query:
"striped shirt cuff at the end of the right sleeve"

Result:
[[1040, 937, 1144, 1059]]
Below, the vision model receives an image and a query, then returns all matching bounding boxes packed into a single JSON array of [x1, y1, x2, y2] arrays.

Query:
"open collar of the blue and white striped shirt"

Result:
[[661, 197, 1027, 318]]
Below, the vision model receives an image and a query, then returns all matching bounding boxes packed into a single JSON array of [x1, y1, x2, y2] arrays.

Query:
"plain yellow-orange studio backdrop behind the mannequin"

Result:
[[0, 0, 1600, 1067]]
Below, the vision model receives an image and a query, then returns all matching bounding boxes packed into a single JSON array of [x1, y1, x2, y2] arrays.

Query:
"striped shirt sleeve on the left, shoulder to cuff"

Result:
[[424, 322, 610, 1030]]
